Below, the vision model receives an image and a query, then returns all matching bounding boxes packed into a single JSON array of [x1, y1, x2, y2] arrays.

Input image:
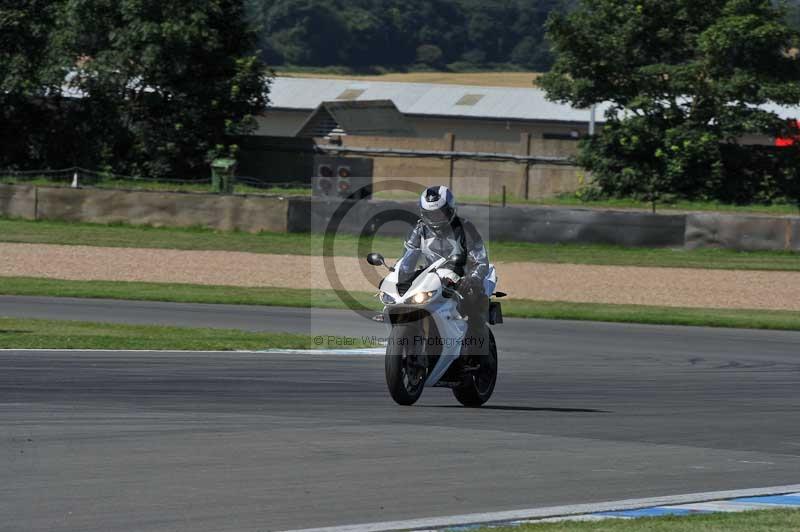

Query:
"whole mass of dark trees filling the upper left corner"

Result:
[[0, 0, 268, 177]]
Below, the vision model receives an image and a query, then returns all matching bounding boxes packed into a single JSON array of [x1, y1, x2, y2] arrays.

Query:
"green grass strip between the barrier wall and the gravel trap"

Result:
[[0, 220, 800, 271]]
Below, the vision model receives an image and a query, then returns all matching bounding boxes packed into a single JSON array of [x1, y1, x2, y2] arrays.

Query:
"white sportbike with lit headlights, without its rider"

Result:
[[367, 253, 505, 407]]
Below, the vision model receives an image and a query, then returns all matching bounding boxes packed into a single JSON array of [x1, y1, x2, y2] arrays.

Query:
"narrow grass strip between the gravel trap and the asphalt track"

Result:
[[0, 277, 800, 331]]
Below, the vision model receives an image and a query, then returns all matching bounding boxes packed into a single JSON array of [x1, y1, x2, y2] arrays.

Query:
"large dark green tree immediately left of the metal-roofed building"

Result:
[[53, 0, 268, 177]]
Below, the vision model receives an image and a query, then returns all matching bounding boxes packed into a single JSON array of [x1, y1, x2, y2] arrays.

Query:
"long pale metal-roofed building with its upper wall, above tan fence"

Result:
[[259, 77, 606, 142]]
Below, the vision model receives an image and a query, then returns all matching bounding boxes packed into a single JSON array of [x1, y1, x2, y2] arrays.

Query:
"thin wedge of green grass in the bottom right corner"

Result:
[[479, 510, 800, 532]]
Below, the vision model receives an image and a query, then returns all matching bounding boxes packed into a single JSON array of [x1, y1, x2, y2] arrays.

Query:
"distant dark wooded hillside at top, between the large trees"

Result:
[[251, 0, 571, 70]]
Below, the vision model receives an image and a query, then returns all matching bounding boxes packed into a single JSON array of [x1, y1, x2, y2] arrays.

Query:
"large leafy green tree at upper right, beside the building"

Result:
[[539, 0, 800, 206]]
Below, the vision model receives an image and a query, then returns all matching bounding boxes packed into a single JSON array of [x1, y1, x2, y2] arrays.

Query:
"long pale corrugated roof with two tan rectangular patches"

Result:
[[270, 77, 605, 122]]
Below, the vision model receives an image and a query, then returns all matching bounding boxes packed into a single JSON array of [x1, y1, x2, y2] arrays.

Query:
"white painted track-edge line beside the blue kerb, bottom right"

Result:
[[280, 484, 800, 532]]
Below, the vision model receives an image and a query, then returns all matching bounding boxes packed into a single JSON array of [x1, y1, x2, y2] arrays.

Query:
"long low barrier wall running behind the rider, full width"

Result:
[[0, 185, 800, 251]]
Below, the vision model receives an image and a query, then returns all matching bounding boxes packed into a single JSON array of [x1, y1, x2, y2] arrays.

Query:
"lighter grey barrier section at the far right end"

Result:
[[685, 213, 800, 251]]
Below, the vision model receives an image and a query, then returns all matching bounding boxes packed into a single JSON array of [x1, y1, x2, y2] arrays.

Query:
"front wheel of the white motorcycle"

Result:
[[386, 322, 428, 406]]
